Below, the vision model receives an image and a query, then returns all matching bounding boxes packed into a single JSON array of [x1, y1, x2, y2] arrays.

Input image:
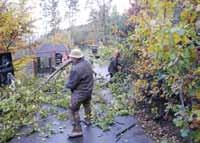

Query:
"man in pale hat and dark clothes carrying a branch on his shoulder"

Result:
[[66, 49, 94, 138]]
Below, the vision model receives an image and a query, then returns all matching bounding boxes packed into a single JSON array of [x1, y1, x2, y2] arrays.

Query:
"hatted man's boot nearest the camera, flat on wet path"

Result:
[[69, 112, 83, 138]]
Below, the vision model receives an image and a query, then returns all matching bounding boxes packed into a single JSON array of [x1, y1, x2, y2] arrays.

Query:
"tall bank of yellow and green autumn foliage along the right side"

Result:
[[118, 0, 200, 142]]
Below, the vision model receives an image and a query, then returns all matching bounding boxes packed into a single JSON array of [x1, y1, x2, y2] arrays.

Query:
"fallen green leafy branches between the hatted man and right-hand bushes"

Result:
[[93, 73, 134, 131]]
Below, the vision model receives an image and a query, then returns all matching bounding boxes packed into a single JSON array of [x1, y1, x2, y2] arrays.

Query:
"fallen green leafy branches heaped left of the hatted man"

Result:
[[0, 69, 70, 142]]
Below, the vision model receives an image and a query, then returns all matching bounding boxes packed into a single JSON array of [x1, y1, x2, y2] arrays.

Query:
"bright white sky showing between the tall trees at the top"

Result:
[[30, 0, 129, 37]]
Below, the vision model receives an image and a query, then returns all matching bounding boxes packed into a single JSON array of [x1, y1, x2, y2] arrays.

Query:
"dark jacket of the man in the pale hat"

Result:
[[66, 59, 94, 99]]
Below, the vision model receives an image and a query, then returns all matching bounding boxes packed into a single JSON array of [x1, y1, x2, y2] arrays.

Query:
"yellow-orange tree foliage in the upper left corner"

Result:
[[0, 0, 33, 52]]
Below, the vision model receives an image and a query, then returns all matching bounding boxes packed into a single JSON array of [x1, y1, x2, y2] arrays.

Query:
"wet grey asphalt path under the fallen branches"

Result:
[[9, 65, 153, 143]]
